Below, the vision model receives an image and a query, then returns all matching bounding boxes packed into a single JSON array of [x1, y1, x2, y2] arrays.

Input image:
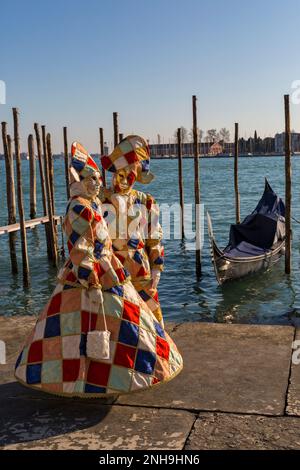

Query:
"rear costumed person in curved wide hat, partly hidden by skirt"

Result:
[[101, 135, 164, 326]]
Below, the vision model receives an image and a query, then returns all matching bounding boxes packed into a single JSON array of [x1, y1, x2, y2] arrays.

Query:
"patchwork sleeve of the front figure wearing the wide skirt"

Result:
[[65, 201, 103, 288]]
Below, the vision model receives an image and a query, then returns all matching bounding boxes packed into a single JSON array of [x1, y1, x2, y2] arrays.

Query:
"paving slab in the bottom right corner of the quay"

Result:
[[185, 413, 300, 450]]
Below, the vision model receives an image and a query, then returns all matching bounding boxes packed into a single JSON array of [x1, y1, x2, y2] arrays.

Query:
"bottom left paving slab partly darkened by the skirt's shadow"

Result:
[[0, 383, 196, 450]]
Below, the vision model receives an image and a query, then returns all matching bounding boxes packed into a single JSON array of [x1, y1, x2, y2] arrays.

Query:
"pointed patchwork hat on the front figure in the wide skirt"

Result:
[[70, 142, 100, 181]]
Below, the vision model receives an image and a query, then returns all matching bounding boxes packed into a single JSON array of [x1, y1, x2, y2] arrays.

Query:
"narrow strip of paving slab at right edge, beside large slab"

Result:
[[286, 328, 300, 416]]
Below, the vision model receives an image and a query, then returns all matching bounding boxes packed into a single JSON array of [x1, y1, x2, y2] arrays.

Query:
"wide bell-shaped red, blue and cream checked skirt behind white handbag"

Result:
[[16, 283, 182, 397]]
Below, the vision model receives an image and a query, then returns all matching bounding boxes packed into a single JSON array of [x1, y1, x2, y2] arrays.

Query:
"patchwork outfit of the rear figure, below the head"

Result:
[[101, 189, 164, 321]]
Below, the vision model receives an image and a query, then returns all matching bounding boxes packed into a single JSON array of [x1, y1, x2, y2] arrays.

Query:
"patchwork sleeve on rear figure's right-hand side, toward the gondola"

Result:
[[146, 194, 164, 271]]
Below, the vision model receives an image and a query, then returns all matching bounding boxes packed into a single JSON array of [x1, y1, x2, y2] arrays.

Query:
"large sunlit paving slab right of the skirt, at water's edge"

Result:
[[117, 323, 294, 415]]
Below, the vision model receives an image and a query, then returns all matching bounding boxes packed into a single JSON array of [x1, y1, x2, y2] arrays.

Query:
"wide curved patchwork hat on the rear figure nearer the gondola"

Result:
[[101, 135, 154, 184]]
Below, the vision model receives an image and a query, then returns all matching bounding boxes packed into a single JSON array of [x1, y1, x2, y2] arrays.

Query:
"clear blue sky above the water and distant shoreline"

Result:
[[0, 0, 300, 152]]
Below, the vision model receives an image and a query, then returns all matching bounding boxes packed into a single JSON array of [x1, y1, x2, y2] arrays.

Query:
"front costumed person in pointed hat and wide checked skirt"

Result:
[[15, 143, 182, 398]]
